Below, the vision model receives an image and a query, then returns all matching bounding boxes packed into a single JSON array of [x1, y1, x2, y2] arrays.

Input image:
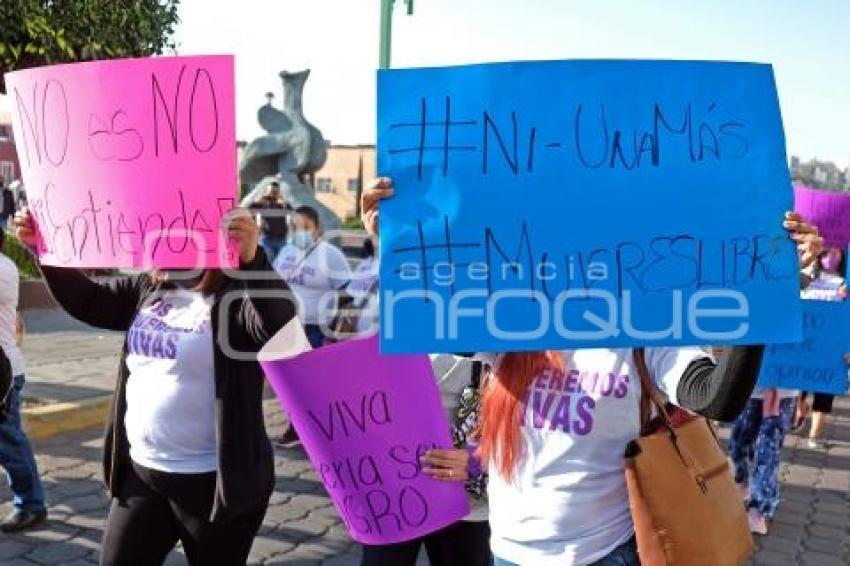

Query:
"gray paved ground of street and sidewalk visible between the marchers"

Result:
[[9, 311, 850, 566]]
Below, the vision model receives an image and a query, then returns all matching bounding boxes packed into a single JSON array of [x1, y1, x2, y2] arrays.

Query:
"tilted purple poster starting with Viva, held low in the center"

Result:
[[261, 330, 469, 544]]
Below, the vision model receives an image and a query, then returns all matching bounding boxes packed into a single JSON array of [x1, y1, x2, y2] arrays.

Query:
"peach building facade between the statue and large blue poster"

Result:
[[314, 145, 376, 220]]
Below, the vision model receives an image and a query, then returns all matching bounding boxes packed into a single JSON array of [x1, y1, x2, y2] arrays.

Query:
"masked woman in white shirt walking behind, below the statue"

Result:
[[274, 206, 351, 448]]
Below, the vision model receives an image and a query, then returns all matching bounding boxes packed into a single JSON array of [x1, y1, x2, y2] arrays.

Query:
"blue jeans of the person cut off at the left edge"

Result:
[[0, 375, 45, 512]]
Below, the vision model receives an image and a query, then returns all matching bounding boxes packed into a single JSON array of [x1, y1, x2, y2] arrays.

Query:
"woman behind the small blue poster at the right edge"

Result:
[[794, 247, 847, 448]]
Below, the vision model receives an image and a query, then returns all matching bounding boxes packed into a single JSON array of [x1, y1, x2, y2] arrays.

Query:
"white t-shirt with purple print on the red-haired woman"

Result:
[[485, 348, 707, 566]]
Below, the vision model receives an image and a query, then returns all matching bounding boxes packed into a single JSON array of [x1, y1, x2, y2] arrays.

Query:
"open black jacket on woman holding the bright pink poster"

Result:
[[42, 249, 295, 521]]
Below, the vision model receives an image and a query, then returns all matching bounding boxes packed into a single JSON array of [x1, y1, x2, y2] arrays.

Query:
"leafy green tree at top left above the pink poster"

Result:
[[0, 0, 180, 92]]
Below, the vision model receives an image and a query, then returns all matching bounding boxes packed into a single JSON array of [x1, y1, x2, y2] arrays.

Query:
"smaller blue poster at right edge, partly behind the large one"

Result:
[[758, 300, 850, 395]]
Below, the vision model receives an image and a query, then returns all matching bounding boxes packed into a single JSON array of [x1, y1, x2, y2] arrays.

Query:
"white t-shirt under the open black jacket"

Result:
[[124, 289, 217, 474]]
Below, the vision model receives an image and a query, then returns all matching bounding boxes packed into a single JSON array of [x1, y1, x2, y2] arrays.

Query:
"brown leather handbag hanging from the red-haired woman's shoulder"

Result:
[[626, 349, 753, 566]]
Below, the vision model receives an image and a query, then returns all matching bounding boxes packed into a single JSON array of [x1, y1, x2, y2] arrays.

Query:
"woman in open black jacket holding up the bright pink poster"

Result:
[[9, 209, 295, 566]]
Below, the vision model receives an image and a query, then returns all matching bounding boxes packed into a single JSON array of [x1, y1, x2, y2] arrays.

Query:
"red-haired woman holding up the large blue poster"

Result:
[[362, 179, 823, 566]]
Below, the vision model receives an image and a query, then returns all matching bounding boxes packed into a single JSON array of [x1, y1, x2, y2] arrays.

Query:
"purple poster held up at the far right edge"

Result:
[[794, 185, 850, 248]]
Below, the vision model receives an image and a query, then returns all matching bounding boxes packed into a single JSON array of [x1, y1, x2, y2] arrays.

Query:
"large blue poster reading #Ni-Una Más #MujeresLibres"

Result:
[[378, 61, 802, 353]]
